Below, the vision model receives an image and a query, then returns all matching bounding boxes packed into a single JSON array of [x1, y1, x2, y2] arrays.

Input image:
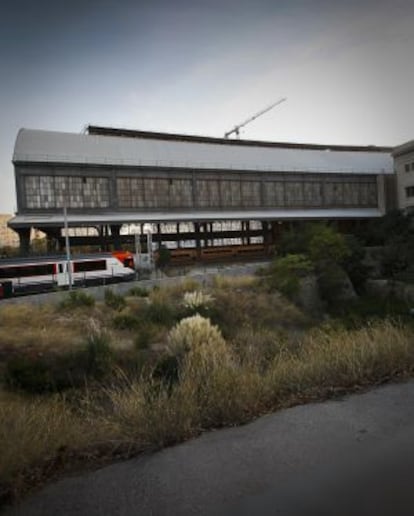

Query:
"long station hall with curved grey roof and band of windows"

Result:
[[9, 126, 395, 252]]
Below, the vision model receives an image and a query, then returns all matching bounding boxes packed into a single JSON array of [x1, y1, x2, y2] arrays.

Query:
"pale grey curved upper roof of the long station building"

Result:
[[13, 128, 393, 174]]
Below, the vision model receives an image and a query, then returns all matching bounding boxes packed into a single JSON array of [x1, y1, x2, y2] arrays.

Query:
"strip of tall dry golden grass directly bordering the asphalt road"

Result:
[[0, 321, 414, 500]]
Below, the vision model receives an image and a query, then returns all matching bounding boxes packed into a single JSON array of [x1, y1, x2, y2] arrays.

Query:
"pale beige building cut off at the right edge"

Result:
[[392, 140, 414, 212]]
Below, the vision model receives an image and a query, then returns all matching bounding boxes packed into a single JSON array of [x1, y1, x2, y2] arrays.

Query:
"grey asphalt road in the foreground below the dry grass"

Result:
[[6, 382, 414, 516]]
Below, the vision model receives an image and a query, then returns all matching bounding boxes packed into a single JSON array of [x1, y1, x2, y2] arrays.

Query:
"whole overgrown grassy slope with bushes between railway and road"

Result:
[[0, 278, 414, 506]]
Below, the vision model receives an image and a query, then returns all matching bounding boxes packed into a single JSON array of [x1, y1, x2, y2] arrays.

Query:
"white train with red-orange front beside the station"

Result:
[[0, 252, 135, 298]]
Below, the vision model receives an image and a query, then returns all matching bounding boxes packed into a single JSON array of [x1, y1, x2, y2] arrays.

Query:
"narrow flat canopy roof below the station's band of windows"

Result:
[[8, 208, 382, 229]]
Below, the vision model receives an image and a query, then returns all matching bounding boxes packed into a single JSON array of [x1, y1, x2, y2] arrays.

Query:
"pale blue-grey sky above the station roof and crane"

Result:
[[0, 0, 414, 213]]
